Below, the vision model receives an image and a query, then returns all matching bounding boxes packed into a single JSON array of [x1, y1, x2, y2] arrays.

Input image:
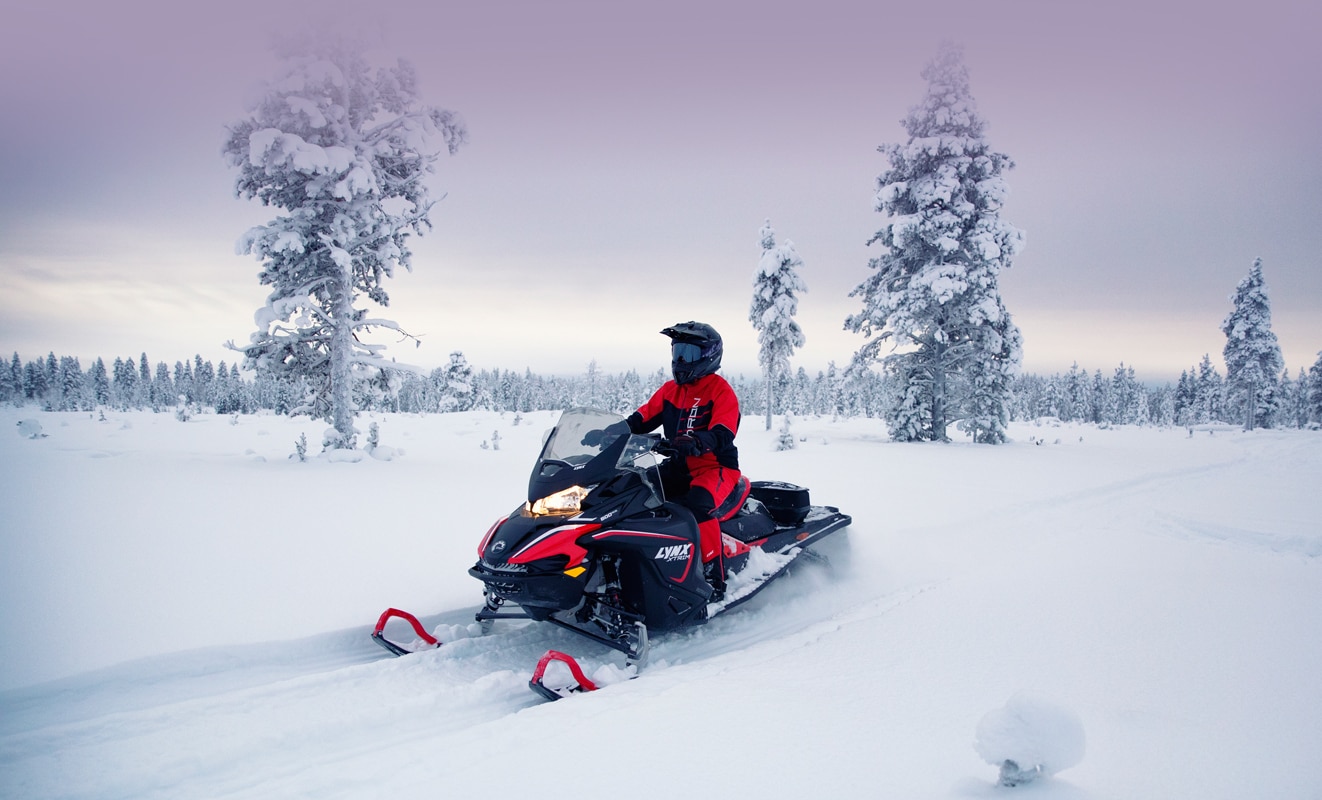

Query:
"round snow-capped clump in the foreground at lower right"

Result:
[[973, 692, 1084, 787]]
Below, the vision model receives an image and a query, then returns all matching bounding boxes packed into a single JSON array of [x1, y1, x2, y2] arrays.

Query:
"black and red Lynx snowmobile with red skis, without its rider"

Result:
[[373, 409, 851, 700]]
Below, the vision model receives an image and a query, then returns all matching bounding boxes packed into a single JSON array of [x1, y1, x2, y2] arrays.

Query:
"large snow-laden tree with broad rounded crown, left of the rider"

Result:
[[223, 42, 467, 448]]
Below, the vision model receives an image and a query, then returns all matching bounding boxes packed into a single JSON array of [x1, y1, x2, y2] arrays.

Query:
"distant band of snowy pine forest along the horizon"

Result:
[[0, 343, 1322, 428]]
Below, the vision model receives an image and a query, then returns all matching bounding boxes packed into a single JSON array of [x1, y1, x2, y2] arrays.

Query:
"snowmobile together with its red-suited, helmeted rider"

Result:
[[371, 321, 851, 700]]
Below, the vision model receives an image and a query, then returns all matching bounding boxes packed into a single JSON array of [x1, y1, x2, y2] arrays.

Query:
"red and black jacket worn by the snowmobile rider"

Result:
[[629, 374, 739, 469]]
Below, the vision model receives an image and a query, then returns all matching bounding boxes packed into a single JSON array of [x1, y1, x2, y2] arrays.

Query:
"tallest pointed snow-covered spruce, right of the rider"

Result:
[[845, 44, 1023, 444]]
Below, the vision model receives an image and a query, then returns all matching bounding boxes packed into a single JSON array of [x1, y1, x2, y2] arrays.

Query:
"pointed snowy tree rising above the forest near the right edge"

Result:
[[1222, 258, 1285, 431]]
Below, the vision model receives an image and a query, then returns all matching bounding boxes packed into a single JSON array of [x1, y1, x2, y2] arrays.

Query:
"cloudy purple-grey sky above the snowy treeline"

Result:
[[0, 0, 1322, 381]]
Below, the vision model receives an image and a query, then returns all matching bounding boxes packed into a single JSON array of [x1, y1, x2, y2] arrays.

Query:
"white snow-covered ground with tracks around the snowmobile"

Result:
[[0, 409, 1322, 799]]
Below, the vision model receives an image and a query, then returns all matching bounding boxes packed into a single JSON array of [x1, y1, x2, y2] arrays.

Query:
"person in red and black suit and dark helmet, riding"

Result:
[[628, 321, 739, 596]]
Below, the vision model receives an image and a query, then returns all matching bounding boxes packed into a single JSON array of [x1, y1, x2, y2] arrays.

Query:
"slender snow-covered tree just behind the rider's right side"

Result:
[[748, 220, 808, 431]]
